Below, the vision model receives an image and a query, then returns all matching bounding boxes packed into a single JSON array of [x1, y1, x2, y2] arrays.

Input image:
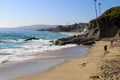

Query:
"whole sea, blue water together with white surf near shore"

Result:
[[0, 29, 76, 63]]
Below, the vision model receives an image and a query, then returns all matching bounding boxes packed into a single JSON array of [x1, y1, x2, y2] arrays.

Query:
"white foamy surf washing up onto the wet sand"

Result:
[[0, 39, 76, 63]]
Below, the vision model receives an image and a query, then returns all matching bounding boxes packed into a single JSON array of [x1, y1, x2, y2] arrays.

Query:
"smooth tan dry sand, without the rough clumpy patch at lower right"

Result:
[[11, 41, 120, 80]]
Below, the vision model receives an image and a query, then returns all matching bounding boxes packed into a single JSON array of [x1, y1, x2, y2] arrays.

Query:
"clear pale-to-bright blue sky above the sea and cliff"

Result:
[[0, 0, 120, 28]]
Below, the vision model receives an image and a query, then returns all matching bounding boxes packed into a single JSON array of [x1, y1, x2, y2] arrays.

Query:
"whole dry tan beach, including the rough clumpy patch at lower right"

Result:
[[12, 41, 120, 80]]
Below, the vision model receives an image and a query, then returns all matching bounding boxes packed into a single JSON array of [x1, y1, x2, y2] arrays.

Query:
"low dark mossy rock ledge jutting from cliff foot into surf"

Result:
[[55, 35, 95, 45]]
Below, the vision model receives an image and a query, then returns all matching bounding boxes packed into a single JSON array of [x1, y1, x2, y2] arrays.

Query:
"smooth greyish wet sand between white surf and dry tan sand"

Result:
[[0, 46, 88, 80]]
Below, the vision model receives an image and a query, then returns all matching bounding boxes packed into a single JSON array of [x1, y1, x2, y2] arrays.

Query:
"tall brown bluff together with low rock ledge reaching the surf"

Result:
[[55, 6, 120, 45]]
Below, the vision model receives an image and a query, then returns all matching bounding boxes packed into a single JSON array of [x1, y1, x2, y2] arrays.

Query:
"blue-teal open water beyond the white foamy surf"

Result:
[[0, 29, 69, 49]]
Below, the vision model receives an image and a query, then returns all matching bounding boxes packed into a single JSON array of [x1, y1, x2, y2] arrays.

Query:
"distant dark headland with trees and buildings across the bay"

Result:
[[38, 23, 88, 32]]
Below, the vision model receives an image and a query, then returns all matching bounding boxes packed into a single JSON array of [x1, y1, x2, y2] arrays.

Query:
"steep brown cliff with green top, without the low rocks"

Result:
[[88, 6, 120, 38]]
